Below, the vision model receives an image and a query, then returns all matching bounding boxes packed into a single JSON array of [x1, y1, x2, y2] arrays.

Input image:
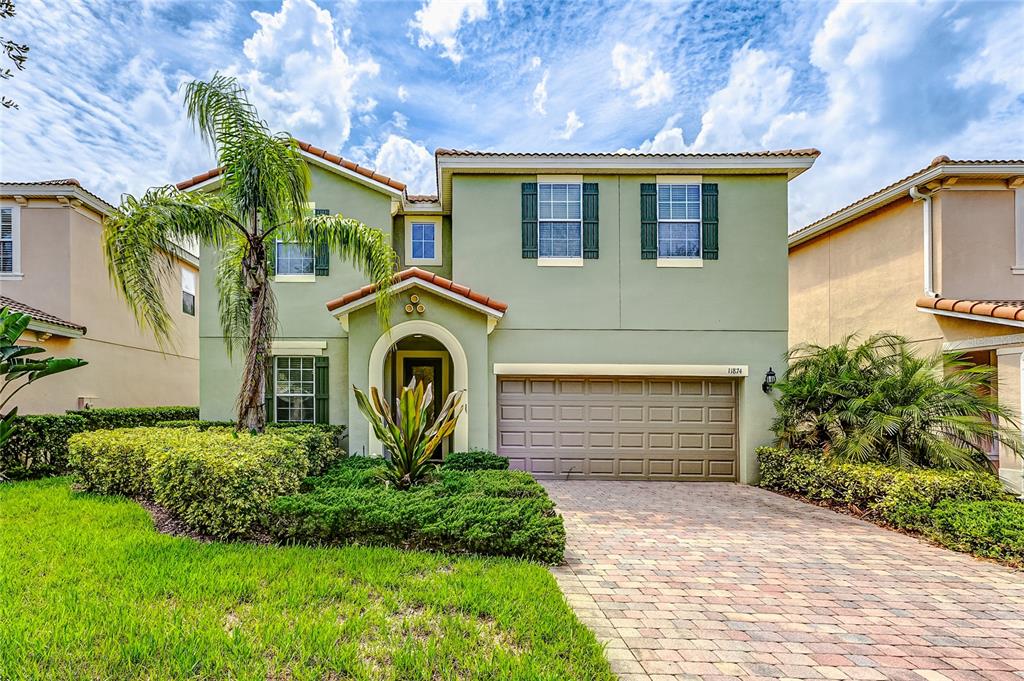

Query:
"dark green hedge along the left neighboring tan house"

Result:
[[0, 407, 199, 480]]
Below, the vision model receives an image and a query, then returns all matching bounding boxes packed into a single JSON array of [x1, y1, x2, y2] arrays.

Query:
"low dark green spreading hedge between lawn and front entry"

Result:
[[270, 457, 565, 563]]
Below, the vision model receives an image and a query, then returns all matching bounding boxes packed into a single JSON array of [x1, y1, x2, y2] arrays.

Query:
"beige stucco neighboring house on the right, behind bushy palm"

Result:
[[790, 156, 1024, 490]]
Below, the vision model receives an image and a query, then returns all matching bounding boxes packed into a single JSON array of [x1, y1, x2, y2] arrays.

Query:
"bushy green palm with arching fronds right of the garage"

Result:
[[773, 334, 1024, 468]]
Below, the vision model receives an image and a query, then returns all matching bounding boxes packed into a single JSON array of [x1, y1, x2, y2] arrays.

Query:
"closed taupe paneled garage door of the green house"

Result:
[[498, 376, 738, 480]]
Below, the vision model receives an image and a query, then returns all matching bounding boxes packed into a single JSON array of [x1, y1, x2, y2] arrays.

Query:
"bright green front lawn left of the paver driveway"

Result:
[[0, 478, 614, 681]]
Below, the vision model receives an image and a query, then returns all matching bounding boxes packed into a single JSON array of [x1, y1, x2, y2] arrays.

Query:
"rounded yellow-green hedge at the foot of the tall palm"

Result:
[[69, 427, 343, 539]]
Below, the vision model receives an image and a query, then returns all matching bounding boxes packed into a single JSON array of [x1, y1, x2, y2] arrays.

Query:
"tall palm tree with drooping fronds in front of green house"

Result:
[[103, 74, 397, 431]]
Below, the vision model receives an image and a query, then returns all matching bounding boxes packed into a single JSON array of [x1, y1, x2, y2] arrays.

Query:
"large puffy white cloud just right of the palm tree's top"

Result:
[[236, 0, 380, 148]]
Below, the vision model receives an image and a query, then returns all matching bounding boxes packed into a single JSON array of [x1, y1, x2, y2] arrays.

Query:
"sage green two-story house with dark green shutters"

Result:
[[188, 143, 818, 481]]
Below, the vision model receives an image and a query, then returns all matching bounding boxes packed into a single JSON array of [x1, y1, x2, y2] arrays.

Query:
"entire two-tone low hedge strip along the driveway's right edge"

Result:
[[758, 448, 1024, 559]]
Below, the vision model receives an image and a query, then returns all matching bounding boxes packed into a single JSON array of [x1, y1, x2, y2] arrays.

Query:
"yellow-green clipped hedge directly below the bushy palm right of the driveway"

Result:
[[758, 448, 1007, 529]]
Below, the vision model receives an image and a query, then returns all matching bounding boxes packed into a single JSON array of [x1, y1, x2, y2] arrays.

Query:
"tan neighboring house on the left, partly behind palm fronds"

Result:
[[0, 179, 199, 414]]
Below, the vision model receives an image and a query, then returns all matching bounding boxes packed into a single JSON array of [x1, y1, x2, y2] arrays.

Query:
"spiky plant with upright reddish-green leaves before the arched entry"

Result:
[[352, 377, 465, 490]]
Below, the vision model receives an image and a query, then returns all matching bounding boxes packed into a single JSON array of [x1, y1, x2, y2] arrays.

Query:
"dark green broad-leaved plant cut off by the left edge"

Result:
[[0, 307, 88, 446]]
